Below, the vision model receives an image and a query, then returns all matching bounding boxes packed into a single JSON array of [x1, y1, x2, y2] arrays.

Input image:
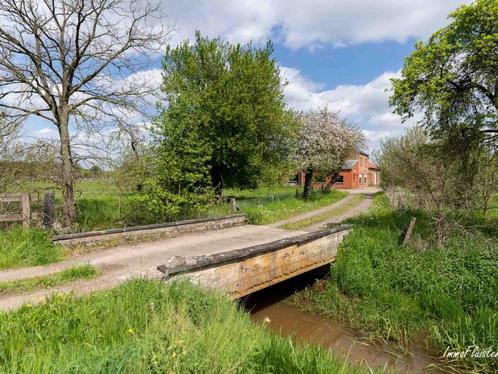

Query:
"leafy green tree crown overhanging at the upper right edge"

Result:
[[390, 0, 498, 149]]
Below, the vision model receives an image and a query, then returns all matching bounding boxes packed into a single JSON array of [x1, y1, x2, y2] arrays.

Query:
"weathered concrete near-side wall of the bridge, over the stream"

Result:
[[158, 225, 351, 299]]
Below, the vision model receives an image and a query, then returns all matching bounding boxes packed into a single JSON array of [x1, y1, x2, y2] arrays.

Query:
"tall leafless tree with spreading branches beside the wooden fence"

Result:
[[0, 0, 170, 224]]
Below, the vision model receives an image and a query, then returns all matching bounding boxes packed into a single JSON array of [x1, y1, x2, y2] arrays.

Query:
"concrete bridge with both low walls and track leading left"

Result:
[[0, 193, 369, 310]]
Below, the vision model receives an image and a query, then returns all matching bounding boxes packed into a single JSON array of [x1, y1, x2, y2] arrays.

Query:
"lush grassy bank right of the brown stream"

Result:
[[292, 195, 498, 372]]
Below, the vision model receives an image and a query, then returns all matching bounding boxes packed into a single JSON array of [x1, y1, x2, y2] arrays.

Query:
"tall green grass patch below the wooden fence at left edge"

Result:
[[0, 227, 62, 269]]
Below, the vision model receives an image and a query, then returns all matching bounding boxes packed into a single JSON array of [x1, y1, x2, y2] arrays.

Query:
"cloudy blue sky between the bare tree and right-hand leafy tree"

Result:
[[20, 0, 468, 150]]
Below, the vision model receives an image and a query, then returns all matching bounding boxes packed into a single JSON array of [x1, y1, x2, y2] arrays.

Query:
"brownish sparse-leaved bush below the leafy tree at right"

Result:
[[379, 126, 498, 246]]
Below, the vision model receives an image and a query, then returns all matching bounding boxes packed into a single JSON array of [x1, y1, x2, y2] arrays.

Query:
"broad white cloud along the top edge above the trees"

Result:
[[164, 0, 469, 49]]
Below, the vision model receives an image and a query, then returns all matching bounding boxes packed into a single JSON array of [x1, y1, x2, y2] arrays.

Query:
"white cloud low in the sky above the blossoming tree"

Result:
[[281, 67, 407, 148]]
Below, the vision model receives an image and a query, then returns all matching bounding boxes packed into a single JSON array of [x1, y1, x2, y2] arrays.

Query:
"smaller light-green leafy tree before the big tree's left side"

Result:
[[127, 110, 214, 223]]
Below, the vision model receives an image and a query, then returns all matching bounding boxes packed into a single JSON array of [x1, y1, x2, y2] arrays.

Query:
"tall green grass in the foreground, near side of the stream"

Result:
[[0, 280, 361, 373]]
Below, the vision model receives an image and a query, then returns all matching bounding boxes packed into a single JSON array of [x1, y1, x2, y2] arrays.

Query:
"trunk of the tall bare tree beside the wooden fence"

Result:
[[59, 114, 76, 226]]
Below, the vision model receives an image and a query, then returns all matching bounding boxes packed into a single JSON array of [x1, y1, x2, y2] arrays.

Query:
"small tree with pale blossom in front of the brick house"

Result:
[[295, 107, 365, 198]]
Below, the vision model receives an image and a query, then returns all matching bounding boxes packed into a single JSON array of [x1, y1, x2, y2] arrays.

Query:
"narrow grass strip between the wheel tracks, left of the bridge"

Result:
[[0, 265, 100, 293]]
